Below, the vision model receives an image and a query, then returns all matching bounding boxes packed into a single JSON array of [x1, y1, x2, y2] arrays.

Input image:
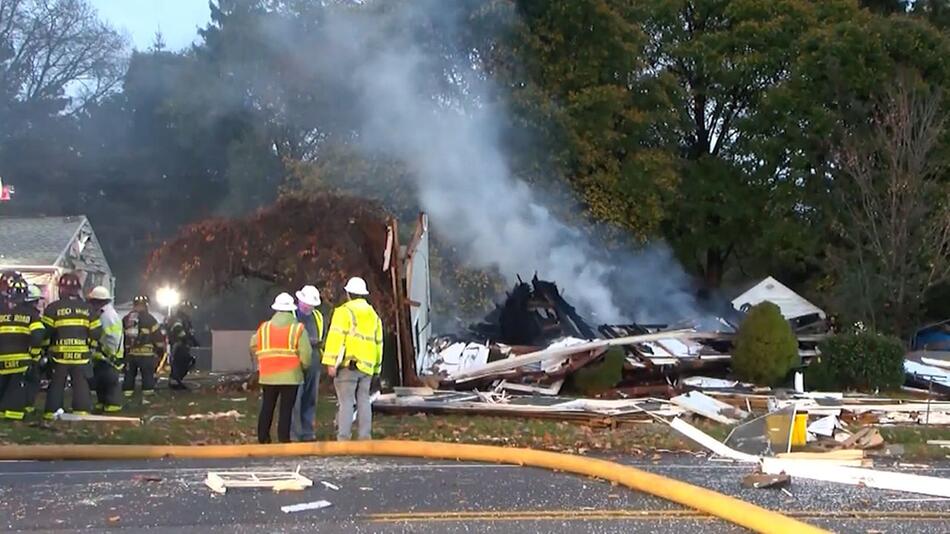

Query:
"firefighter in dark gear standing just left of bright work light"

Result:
[[122, 295, 165, 397]]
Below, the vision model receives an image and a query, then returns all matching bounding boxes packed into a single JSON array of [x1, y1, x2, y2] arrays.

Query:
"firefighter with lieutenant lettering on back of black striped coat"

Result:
[[43, 273, 101, 419]]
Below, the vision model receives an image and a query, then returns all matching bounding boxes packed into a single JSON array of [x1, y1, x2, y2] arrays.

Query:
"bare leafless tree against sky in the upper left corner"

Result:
[[0, 0, 126, 126]]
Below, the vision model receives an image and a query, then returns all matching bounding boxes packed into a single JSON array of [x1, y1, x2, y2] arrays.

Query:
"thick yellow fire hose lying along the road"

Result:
[[0, 440, 826, 534]]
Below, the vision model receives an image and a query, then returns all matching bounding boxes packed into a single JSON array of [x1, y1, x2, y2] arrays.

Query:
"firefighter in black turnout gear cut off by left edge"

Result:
[[0, 279, 45, 421]]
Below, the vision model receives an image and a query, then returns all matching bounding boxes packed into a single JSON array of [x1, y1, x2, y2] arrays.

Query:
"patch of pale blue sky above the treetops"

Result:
[[89, 0, 211, 50]]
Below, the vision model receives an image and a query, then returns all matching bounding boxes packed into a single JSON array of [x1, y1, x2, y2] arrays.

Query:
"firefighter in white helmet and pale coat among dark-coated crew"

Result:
[[87, 286, 125, 413]]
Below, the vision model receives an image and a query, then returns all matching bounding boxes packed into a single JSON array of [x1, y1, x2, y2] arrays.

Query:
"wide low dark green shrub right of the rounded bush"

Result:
[[805, 332, 905, 391]]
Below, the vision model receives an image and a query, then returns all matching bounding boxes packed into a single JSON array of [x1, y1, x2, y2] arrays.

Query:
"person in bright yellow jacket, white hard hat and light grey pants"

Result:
[[323, 278, 383, 441]]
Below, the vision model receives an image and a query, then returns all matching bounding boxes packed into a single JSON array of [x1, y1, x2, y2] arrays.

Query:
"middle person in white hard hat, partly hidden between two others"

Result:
[[293, 286, 323, 441]]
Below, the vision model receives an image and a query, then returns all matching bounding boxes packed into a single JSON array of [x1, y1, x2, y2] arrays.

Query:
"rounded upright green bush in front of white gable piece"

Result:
[[732, 302, 799, 386]]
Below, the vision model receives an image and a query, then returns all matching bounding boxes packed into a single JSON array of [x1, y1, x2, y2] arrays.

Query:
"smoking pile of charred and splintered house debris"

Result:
[[410, 276, 822, 410]]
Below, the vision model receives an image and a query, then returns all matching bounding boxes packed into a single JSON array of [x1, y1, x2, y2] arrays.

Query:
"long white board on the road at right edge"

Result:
[[762, 458, 950, 497]]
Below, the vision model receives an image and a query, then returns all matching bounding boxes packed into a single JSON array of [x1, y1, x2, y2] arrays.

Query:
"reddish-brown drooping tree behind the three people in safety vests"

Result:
[[145, 194, 394, 324]]
